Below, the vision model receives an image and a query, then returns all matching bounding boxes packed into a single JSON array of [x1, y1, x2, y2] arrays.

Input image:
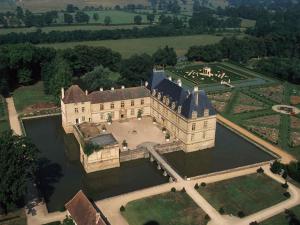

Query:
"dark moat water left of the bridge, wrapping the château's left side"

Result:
[[24, 117, 168, 212]]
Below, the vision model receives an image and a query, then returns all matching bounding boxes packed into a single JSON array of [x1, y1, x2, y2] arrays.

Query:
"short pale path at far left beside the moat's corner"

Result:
[[6, 97, 22, 135]]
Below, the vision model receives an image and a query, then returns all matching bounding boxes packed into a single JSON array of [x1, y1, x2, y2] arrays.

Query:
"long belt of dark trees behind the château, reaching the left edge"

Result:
[[0, 44, 177, 99]]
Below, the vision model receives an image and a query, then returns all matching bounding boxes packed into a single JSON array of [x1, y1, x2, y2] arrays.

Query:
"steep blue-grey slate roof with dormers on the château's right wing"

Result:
[[147, 71, 216, 119]]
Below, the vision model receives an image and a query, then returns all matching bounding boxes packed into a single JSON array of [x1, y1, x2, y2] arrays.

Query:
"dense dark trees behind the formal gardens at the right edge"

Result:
[[186, 37, 300, 83]]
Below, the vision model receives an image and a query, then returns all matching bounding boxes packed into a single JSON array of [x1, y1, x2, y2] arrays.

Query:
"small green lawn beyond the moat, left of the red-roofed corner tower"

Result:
[[13, 82, 54, 112]]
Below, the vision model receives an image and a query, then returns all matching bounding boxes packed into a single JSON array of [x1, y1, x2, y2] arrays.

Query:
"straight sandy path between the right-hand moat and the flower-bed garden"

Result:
[[217, 114, 296, 163]]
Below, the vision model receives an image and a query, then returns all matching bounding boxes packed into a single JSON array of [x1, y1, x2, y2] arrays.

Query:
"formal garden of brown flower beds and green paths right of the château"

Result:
[[208, 78, 300, 158]]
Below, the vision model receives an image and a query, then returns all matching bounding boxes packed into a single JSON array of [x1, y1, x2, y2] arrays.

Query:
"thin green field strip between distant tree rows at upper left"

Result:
[[0, 24, 148, 35]]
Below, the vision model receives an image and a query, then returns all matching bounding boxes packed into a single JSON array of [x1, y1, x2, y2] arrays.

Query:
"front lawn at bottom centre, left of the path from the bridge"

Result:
[[122, 192, 207, 225]]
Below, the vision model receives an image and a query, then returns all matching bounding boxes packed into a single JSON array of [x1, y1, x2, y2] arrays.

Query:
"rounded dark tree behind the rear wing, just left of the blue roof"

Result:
[[119, 54, 153, 86]]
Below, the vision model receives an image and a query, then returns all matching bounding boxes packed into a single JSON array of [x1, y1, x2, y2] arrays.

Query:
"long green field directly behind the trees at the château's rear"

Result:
[[40, 34, 241, 57]]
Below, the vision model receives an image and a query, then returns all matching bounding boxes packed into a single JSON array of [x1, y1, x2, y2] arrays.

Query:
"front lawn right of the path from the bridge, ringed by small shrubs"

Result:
[[198, 174, 287, 216]]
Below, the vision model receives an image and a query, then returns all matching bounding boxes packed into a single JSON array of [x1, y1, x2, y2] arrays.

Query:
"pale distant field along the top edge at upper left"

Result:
[[0, 0, 149, 12]]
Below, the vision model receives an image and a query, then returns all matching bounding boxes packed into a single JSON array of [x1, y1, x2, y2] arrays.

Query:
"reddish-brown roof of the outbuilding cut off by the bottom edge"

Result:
[[65, 190, 106, 225]]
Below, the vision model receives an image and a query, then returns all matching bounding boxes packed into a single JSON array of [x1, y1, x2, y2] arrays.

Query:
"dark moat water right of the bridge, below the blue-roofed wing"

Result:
[[163, 124, 274, 177]]
